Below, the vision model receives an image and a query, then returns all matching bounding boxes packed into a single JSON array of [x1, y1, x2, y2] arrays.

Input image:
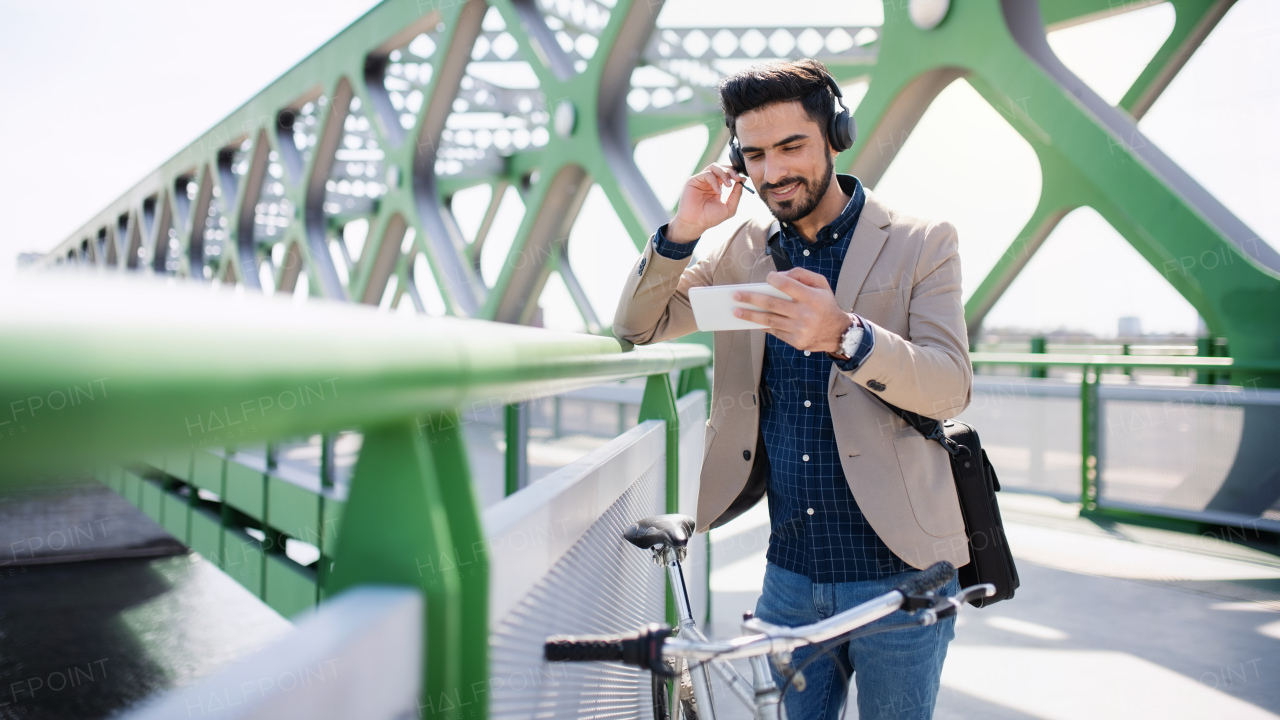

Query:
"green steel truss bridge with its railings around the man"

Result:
[[10, 0, 1280, 717]]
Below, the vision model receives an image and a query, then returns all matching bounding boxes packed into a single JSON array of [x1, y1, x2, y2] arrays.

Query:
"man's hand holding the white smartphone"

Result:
[[733, 268, 856, 355]]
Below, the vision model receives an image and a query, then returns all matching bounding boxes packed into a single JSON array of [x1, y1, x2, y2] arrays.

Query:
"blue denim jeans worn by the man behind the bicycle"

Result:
[[755, 562, 959, 720]]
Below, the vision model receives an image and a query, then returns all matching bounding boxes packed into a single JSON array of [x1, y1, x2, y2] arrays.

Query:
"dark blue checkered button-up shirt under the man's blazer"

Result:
[[654, 176, 910, 583]]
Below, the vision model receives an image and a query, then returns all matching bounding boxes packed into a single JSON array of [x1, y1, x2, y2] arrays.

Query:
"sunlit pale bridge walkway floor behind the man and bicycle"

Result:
[[712, 492, 1280, 720]]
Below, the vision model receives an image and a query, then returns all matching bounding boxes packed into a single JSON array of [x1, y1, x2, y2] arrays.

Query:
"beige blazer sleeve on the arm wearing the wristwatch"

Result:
[[845, 223, 973, 420]]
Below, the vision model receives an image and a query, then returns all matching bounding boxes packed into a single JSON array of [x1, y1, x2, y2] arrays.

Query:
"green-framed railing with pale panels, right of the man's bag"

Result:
[[961, 352, 1280, 533]]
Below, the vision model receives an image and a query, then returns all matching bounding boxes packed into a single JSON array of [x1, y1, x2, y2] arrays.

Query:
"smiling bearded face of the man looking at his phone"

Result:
[[737, 100, 835, 222]]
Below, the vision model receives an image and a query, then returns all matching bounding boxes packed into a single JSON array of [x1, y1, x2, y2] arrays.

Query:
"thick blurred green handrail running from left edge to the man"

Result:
[[0, 277, 710, 476]]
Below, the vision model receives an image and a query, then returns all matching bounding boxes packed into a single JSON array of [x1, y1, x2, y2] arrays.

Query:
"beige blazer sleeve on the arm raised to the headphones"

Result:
[[613, 223, 746, 345]]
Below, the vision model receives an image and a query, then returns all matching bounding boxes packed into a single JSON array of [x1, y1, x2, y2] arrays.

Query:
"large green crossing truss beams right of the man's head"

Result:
[[841, 3, 1280, 382]]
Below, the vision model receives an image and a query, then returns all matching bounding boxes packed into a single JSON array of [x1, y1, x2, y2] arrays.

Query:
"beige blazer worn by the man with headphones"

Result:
[[613, 191, 973, 568]]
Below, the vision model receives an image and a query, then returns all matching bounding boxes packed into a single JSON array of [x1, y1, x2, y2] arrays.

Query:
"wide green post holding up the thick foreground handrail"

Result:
[[324, 414, 489, 719]]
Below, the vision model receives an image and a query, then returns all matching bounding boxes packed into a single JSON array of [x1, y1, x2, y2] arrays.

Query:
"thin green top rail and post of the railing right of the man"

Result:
[[969, 351, 1280, 516]]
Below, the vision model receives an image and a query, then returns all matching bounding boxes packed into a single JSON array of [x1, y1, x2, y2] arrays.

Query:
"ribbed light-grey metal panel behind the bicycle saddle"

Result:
[[486, 421, 667, 719]]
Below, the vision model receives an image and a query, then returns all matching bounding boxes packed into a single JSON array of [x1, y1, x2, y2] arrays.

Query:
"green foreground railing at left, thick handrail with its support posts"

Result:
[[0, 277, 710, 717]]
